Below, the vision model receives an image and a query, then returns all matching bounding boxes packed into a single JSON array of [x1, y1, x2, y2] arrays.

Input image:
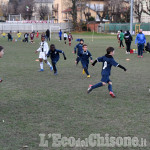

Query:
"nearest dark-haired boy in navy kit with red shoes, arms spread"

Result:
[[87, 47, 126, 98]]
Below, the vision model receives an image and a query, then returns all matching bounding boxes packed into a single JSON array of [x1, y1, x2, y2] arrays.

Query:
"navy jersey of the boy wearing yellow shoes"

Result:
[[79, 50, 92, 63]]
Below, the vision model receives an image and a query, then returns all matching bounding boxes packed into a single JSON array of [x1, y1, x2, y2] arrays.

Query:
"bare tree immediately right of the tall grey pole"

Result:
[[134, 0, 143, 23]]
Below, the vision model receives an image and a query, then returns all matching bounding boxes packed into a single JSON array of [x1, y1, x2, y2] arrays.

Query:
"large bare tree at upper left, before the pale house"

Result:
[[17, 0, 34, 20]]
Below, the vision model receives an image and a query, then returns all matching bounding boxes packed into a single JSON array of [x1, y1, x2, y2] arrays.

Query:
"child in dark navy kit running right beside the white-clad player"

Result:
[[47, 44, 66, 75]]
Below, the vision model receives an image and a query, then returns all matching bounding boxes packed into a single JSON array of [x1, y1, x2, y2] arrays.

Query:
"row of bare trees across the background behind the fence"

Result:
[[0, 0, 150, 25]]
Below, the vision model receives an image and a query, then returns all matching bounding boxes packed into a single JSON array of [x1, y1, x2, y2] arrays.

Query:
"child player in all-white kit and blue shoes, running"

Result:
[[35, 36, 53, 72]]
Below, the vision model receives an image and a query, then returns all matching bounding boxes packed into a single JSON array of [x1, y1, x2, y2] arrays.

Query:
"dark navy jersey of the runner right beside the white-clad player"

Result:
[[47, 49, 64, 61]]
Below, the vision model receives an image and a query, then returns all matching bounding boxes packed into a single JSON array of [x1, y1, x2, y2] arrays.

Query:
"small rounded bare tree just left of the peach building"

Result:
[[38, 5, 50, 20]]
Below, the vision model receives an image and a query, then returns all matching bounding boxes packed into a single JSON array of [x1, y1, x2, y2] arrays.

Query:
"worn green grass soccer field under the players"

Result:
[[0, 34, 150, 150]]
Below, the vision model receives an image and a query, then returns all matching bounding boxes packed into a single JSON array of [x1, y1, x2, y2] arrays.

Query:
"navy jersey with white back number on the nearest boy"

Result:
[[97, 54, 119, 76]]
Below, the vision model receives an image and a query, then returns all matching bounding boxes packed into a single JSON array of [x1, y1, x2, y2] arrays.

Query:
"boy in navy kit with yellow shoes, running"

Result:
[[79, 44, 93, 78]]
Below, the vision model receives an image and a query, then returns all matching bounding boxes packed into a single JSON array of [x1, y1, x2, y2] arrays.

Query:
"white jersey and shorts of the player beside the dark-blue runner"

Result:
[[37, 41, 49, 60]]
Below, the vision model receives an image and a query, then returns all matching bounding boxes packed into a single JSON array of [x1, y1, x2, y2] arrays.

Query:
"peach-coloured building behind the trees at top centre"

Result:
[[53, 0, 105, 23]]
